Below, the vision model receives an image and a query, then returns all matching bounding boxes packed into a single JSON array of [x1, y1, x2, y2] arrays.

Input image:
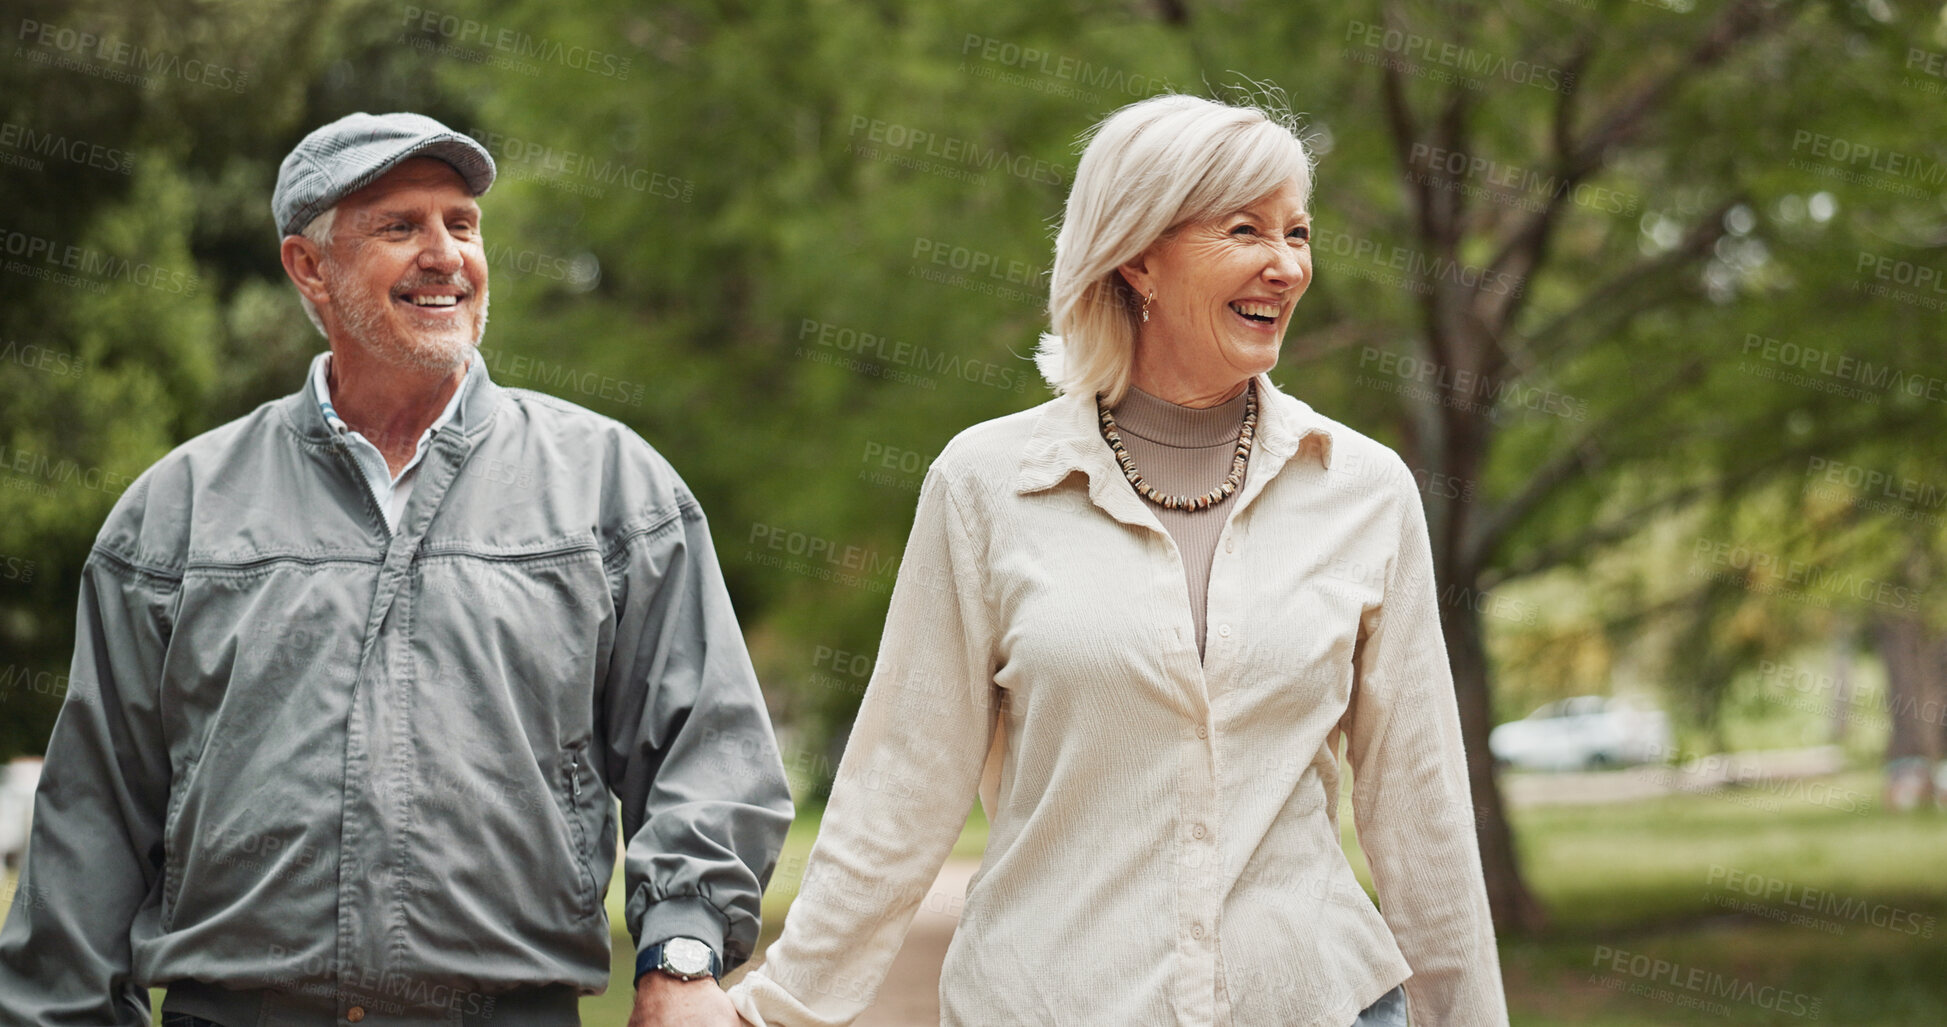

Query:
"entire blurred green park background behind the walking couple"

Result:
[[0, 0, 1947, 1025]]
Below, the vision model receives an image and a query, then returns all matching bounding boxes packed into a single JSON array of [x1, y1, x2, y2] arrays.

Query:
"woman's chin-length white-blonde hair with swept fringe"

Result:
[[1034, 94, 1312, 403]]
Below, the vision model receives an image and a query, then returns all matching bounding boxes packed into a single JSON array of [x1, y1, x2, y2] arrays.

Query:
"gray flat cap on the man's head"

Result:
[[271, 113, 495, 238]]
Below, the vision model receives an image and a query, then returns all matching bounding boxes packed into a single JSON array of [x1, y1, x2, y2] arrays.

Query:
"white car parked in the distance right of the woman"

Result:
[[1488, 696, 1676, 770]]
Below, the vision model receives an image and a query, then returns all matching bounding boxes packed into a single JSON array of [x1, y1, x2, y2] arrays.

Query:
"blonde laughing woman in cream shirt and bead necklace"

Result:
[[730, 95, 1507, 1027]]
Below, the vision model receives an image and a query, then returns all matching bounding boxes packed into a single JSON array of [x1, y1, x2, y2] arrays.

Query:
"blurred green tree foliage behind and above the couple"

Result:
[[0, 0, 1947, 781]]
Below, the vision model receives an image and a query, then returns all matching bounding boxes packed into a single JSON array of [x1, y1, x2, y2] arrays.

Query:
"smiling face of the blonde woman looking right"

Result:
[[1121, 179, 1312, 405]]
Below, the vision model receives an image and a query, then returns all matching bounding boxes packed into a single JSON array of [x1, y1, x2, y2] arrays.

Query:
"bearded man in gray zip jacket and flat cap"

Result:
[[0, 113, 790, 1027]]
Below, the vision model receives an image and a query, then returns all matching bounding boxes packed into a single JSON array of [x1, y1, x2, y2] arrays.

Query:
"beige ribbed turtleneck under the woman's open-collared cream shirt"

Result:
[[1114, 386, 1250, 657]]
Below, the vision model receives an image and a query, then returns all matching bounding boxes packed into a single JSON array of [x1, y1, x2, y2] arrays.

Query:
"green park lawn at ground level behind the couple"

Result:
[[8, 772, 1947, 1027]]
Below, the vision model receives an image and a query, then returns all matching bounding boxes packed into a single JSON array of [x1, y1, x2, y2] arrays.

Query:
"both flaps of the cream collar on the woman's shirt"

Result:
[[1014, 374, 1332, 495]]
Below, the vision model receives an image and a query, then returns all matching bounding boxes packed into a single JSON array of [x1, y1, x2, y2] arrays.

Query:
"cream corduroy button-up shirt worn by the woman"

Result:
[[730, 376, 1507, 1027]]
